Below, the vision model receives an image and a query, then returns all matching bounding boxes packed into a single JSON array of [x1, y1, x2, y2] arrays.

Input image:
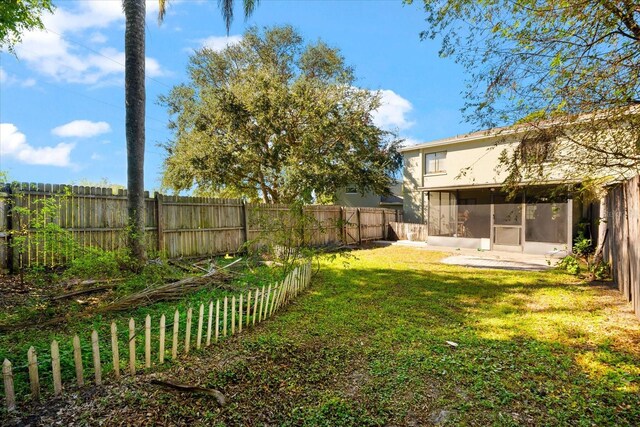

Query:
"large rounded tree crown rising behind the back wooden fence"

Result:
[[161, 26, 400, 203]]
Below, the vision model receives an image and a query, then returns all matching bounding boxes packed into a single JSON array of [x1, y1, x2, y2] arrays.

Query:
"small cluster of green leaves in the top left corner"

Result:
[[0, 0, 54, 52]]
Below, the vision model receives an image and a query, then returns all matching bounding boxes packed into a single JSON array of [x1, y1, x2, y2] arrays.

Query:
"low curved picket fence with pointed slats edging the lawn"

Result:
[[2, 263, 311, 411]]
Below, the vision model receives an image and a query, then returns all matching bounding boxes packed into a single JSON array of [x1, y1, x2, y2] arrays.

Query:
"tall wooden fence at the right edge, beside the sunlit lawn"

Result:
[[605, 175, 640, 318]]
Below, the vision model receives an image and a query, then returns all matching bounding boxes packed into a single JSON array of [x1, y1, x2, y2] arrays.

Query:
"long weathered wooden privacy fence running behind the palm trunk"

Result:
[[0, 183, 402, 268]]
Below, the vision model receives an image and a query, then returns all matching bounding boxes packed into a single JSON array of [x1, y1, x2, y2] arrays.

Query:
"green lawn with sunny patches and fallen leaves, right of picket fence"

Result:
[[5, 247, 640, 426]]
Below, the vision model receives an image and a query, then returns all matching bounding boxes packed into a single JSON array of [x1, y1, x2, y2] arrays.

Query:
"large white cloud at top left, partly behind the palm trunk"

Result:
[[16, 0, 164, 85]]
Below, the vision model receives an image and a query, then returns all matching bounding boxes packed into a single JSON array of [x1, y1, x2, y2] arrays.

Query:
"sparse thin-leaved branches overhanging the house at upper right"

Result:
[[405, 0, 640, 186]]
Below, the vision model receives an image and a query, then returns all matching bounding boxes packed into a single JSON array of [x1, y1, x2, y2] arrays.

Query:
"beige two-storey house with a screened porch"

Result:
[[401, 127, 598, 254]]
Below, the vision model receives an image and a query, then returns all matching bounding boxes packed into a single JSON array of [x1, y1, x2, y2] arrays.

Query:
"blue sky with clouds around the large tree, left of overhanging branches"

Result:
[[0, 0, 472, 190]]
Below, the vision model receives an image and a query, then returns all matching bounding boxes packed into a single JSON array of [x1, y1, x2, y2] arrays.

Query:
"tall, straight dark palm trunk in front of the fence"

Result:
[[123, 0, 146, 266]]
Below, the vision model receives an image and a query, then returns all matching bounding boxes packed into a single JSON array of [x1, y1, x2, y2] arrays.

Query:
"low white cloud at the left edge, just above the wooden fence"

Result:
[[0, 123, 74, 167]]
